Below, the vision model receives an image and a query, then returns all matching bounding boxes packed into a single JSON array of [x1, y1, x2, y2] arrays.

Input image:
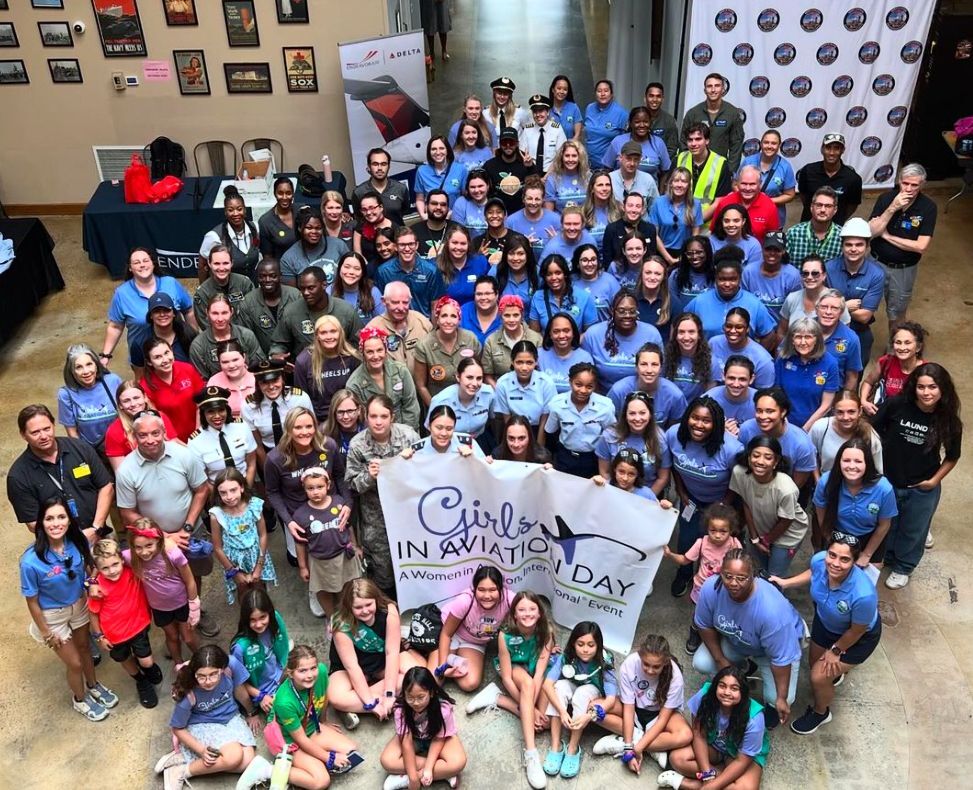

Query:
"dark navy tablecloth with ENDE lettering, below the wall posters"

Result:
[[82, 173, 321, 279]]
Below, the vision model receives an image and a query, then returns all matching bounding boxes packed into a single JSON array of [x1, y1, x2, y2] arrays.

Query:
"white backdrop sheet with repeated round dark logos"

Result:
[[683, 0, 936, 188]]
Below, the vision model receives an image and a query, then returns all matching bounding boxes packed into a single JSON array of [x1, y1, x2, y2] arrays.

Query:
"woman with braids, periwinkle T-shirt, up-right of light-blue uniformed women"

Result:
[[581, 288, 662, 392]]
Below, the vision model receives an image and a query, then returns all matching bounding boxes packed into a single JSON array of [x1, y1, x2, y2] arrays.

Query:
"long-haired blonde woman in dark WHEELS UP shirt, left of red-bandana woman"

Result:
[[294, 315, 361, 420]]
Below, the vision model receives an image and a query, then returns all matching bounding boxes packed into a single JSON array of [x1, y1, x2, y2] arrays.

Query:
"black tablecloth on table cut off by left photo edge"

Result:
[[0, 218, 64, 342]]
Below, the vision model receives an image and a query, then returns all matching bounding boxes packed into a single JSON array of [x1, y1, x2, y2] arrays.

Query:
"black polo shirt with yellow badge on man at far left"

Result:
[[7, 436, 111, 527]]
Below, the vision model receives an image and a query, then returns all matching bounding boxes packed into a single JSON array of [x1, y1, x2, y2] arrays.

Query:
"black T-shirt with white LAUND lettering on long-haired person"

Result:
[[872, 395, 963, 488]]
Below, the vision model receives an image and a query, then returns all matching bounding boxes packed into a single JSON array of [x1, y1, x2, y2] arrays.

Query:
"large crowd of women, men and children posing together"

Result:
[[7, 68, 962, 790]]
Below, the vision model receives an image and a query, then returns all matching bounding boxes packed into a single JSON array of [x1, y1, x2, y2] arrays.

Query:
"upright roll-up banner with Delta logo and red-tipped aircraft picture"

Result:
[[338, 30, 430, 183]]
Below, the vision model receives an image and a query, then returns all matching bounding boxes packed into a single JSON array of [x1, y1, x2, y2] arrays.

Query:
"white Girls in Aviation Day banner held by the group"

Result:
[[378, 454, 676, 653]]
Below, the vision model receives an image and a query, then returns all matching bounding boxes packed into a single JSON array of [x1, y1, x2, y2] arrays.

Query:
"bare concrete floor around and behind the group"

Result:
[[0, 0, 973, 790]]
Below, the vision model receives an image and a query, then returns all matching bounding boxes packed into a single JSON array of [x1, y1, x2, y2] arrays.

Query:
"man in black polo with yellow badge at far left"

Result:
[[7, 404, 115, 538]]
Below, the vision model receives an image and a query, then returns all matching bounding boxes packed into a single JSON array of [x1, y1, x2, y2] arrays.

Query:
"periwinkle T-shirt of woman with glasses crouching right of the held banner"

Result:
[[693, 574, 804, 667]]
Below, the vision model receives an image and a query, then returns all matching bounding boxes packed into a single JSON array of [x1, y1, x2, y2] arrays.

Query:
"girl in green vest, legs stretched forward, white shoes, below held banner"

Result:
[[466, 590, 554, 790]]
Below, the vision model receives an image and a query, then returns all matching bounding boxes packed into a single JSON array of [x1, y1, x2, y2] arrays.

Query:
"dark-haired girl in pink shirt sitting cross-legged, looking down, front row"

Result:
[[381, 667, 466, 790]]
